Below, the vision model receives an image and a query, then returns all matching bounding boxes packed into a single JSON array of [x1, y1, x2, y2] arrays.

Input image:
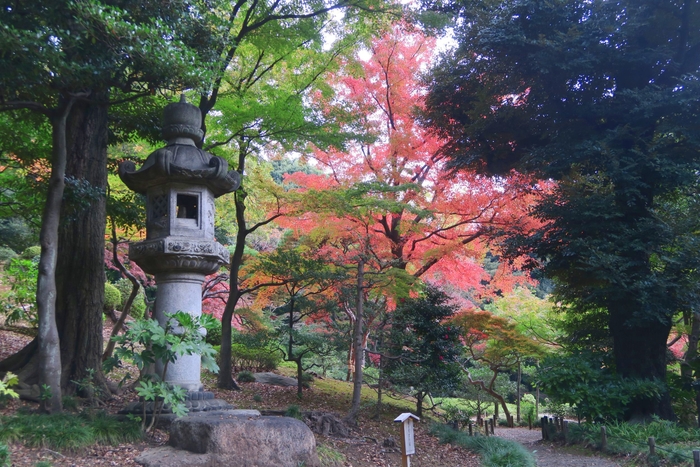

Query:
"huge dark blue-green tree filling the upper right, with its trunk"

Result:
[[426, 0, 700, 417]]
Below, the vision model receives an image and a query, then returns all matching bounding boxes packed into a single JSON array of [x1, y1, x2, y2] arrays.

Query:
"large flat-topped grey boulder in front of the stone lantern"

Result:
[[136, 410, 320, 467]]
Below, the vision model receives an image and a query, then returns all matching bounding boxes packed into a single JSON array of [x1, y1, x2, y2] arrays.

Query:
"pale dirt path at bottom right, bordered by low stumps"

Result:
[[495, 428, 622, 467]]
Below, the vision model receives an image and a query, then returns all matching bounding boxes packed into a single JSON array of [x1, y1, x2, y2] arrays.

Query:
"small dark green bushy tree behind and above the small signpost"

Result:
[[385, 286, 462, 417]]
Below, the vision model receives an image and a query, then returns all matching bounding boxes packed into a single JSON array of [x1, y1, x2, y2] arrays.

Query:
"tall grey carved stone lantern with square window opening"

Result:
[[119, 96, 240, 410]]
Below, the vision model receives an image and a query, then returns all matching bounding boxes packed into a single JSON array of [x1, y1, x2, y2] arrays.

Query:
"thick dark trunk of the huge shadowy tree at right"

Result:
[[609, 309, 675, 421]]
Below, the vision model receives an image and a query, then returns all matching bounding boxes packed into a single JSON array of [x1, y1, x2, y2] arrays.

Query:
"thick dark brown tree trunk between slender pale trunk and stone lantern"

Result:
[[56, 98, 107, 389]]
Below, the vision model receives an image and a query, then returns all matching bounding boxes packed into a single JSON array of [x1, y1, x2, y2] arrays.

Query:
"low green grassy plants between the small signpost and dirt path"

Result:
[[429, 424, 535, 467]]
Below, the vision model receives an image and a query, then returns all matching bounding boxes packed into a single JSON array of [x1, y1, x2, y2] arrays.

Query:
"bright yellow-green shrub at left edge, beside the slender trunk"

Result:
[[0, 258, 39, 327]]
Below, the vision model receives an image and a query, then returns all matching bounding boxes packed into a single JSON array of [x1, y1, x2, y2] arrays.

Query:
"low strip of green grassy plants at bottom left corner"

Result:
[[0, 411, 141, 451]]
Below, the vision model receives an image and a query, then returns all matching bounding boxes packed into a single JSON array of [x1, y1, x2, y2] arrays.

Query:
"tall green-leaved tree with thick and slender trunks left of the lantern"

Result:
[[0, 0, 207, 411]]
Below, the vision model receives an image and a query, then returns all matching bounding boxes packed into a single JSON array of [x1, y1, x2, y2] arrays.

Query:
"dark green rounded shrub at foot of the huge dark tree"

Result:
[[537, 352, 663, 421]]
